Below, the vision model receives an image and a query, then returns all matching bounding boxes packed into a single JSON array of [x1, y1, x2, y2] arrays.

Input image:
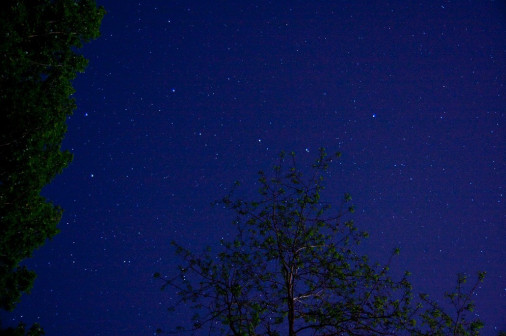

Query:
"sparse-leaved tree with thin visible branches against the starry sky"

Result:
[[155, 149, 483, 336]]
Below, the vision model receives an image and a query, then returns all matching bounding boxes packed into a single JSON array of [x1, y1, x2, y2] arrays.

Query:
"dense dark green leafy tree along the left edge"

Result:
[[0, 0, 105, 330]]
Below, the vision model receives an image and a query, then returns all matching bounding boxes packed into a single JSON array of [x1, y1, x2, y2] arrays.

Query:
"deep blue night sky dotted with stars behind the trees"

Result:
[[1, 0, 506, 336]]
